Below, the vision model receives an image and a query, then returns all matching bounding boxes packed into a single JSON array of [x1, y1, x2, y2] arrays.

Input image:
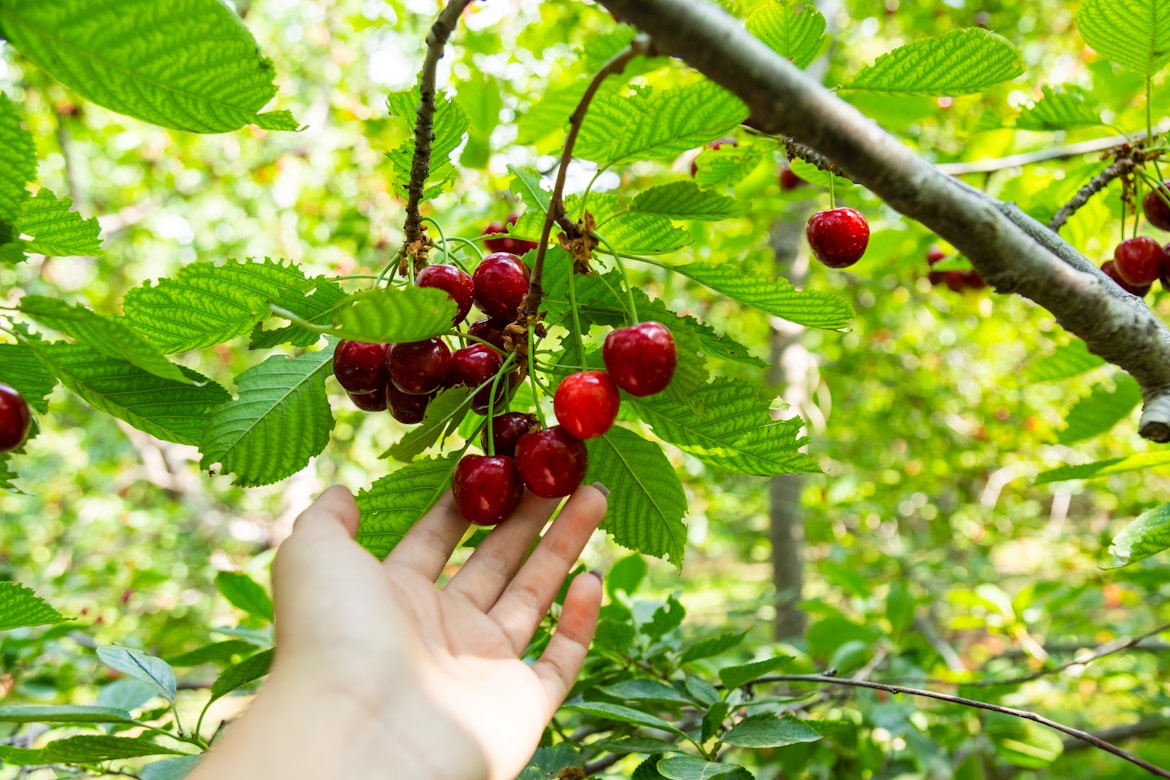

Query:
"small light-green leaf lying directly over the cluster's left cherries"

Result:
[[330, 287, 455, 344]]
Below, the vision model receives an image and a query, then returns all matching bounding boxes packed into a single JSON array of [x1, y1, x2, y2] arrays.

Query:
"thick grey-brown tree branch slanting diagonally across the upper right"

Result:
[[601, 0, 1170, 442]]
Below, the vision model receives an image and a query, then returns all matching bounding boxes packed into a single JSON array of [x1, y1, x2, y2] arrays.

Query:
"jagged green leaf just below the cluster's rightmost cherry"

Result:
[[629, 378, 820, 476]]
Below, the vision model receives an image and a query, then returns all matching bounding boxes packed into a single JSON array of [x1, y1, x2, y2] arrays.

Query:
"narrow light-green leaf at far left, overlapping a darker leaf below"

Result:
[[20, 295, 194, 385]]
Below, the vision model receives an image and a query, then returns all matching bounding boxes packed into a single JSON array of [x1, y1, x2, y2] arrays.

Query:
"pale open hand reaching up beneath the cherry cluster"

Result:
[[188, 486, 606, 780]]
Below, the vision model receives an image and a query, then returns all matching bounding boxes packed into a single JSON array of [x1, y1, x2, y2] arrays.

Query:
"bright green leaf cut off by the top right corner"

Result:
[[1076, 0, 1170, 76]]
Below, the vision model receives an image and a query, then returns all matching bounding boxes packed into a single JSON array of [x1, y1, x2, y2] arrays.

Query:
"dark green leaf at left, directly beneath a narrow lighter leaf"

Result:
[[33, 344, 230, 444]]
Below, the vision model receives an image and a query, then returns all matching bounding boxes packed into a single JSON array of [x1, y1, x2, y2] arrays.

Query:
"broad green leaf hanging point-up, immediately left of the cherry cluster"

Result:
[[199, 345, 333, 488]]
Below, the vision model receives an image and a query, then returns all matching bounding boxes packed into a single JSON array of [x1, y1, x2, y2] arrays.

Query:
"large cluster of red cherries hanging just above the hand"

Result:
[[333, 216, 677, 525]]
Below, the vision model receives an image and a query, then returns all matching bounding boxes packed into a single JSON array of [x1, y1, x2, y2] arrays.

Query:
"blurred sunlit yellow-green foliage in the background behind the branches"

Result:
[[0, 0, 1170, 778]]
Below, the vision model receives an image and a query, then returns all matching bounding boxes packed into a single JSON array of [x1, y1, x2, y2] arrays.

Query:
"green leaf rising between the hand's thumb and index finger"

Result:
[[357, 455, 459, 558]]
